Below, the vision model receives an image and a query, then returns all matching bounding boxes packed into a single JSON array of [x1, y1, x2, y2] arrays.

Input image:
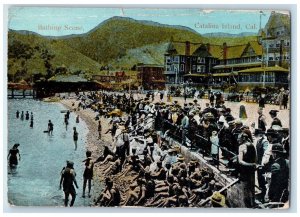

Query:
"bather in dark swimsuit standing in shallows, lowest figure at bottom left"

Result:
[[59, 161, 78, 207]]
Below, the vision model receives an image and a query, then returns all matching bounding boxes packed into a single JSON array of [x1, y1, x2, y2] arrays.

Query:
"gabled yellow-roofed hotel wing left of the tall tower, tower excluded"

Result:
[[165, 41, 262, 86]]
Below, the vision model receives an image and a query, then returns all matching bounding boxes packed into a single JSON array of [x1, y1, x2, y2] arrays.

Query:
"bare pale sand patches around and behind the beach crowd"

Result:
[[60, 92, 289, 206]]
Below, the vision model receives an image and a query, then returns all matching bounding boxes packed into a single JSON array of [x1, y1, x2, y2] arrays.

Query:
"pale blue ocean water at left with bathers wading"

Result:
[[7, 99, 90, 206]]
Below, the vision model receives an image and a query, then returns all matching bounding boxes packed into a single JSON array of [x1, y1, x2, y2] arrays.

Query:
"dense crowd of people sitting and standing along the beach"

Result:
[[57, 88, 290, 208]]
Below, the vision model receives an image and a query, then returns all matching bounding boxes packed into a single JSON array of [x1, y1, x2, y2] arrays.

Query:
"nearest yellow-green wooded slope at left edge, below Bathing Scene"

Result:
[[8, 31, 101, 81]]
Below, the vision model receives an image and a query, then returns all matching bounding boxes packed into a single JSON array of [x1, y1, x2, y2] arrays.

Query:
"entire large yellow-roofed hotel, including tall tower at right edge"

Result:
[[164, 12, 290, 87]]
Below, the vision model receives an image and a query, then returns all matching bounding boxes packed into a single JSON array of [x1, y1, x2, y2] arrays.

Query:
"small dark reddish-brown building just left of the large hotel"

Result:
[[137, 64, 166, 90]]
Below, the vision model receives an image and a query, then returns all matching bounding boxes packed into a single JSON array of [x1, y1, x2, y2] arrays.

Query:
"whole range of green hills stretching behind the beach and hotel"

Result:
[[8, 17, 255, 81]]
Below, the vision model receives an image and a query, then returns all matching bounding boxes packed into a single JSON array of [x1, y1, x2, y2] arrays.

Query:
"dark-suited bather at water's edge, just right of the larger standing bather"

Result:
[[82, 151, 94, 198]]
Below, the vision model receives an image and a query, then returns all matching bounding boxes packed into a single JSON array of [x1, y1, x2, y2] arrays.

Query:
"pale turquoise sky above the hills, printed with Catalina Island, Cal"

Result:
[[7, 6, 284, 36]]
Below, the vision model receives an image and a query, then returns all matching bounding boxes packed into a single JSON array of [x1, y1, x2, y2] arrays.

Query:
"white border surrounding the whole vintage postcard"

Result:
[[0, 0, 300, 216]]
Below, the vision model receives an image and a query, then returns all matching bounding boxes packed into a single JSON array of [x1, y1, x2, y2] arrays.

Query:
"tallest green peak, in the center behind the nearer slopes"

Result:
[[62, 17, 202, 64]]
